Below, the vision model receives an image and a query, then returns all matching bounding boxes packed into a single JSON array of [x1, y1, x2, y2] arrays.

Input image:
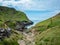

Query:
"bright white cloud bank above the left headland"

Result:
[[0, 0, 32, 10]]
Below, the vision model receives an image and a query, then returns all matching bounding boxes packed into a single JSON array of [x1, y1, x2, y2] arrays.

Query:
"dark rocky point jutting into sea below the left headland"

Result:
[[15, 21, 33, 31]]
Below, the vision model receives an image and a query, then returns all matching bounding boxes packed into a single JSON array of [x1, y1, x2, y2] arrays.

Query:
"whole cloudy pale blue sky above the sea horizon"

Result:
[[0, 0, 60, 11]]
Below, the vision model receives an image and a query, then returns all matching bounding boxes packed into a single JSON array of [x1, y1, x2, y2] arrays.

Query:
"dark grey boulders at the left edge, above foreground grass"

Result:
[[0, 28, 11, 40]]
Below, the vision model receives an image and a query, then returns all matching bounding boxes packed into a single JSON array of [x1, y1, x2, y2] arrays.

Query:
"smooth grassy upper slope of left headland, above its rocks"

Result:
[[0, 6, 28, 21]]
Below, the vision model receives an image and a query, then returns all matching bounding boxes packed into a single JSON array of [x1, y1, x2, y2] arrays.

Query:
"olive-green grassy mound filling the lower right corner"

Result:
[[35, 27, 60, 45]]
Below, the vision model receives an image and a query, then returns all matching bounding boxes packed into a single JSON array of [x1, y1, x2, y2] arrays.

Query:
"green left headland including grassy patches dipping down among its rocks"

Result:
[[0, 6, 29, 28]]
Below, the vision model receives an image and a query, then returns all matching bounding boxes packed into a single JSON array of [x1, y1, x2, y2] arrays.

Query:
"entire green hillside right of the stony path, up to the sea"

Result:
[[35, 13, 60, 45]]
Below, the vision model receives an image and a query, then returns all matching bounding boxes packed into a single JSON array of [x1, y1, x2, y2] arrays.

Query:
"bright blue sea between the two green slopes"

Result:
[[24, 11, 58, 26]]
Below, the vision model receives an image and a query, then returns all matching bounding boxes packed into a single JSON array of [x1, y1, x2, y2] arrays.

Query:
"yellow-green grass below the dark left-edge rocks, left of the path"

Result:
[[0, 30, 23, 45]]
